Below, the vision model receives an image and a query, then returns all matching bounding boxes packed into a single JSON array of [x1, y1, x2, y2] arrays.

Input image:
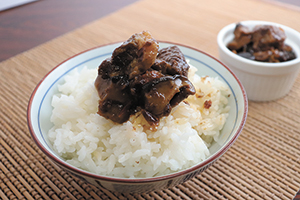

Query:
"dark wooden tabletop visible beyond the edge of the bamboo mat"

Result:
[[0, 0, 300, 61]]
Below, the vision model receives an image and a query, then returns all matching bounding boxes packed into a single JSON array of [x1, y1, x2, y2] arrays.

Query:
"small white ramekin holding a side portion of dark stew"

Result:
[[217, 21, 300, 101]]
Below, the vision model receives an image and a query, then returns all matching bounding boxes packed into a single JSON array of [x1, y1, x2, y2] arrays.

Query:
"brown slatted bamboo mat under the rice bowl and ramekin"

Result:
[[0, 0, 300, 199]]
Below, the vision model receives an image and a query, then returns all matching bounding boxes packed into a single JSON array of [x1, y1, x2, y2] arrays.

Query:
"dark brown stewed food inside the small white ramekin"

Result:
[[227, 23, 296, 63]]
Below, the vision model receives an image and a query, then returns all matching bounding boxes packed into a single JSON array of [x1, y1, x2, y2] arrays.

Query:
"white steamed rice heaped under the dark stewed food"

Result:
[[48, 66, 230, 178]]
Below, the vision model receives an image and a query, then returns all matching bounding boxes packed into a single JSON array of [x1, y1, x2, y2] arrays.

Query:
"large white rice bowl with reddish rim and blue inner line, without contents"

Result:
[[27, 42, 248, 193]]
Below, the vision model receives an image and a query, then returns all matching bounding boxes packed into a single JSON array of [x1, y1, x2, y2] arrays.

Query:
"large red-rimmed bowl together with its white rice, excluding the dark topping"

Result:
[[27, 42, 248, 193]]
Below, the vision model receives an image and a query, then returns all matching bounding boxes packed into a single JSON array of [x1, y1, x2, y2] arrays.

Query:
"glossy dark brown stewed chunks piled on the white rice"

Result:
[[95, 31, 195, 125]]
